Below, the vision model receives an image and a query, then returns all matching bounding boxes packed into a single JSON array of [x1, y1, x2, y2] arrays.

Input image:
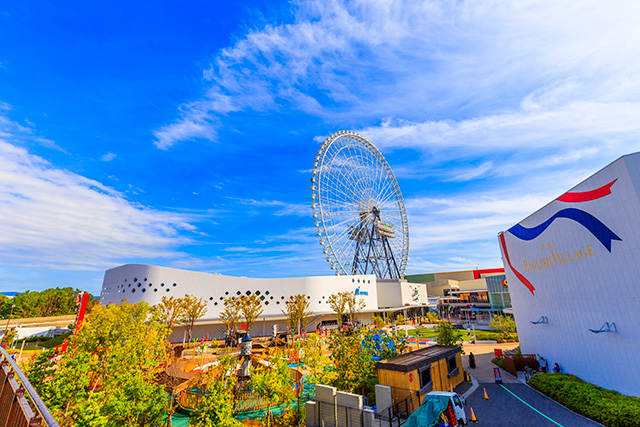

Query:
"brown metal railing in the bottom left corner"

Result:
[[0, 348, 59, 427]]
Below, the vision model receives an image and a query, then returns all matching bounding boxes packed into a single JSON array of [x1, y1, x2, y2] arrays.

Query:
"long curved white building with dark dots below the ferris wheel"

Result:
[[100, 264, 428, 341]]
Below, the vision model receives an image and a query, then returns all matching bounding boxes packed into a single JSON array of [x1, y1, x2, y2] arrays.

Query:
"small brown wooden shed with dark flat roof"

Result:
[[376, 345, 464, 401]]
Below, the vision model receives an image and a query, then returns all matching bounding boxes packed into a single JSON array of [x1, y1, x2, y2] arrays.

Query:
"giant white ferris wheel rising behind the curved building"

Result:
[[311, 131, 409, 279]]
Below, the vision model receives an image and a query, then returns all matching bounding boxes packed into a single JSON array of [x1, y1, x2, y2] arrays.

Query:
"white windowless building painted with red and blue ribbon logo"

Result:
[[498, 153, 640, 396]]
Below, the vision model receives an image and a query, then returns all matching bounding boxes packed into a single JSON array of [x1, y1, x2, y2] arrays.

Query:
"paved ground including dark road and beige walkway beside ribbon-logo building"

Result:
[[462, 343, 601, 427]]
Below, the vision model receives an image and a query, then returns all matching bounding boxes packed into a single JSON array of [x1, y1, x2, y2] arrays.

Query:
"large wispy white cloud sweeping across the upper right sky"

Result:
[[146, 0, 640, 278]]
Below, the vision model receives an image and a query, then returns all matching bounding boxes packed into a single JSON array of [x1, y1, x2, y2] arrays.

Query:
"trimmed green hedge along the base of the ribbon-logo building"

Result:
[[529, 373, 640, 427]]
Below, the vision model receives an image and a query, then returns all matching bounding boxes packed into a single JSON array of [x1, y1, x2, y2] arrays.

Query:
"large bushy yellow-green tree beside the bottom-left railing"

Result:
[[27, 302, 168, 427]]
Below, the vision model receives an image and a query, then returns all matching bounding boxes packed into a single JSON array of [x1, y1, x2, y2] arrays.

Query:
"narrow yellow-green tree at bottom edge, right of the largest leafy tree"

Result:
[[189, 356, 242, 427]]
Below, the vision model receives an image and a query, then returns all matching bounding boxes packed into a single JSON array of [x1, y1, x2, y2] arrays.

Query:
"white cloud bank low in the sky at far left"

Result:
[[0, 115, 194, 270]]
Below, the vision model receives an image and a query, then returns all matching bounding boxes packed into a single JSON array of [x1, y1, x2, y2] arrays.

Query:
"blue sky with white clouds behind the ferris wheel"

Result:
[[0, 1, 640, 294]]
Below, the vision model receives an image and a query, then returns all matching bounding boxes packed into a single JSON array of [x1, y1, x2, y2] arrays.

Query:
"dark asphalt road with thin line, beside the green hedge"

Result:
[[466, 383, 601, 427]]
